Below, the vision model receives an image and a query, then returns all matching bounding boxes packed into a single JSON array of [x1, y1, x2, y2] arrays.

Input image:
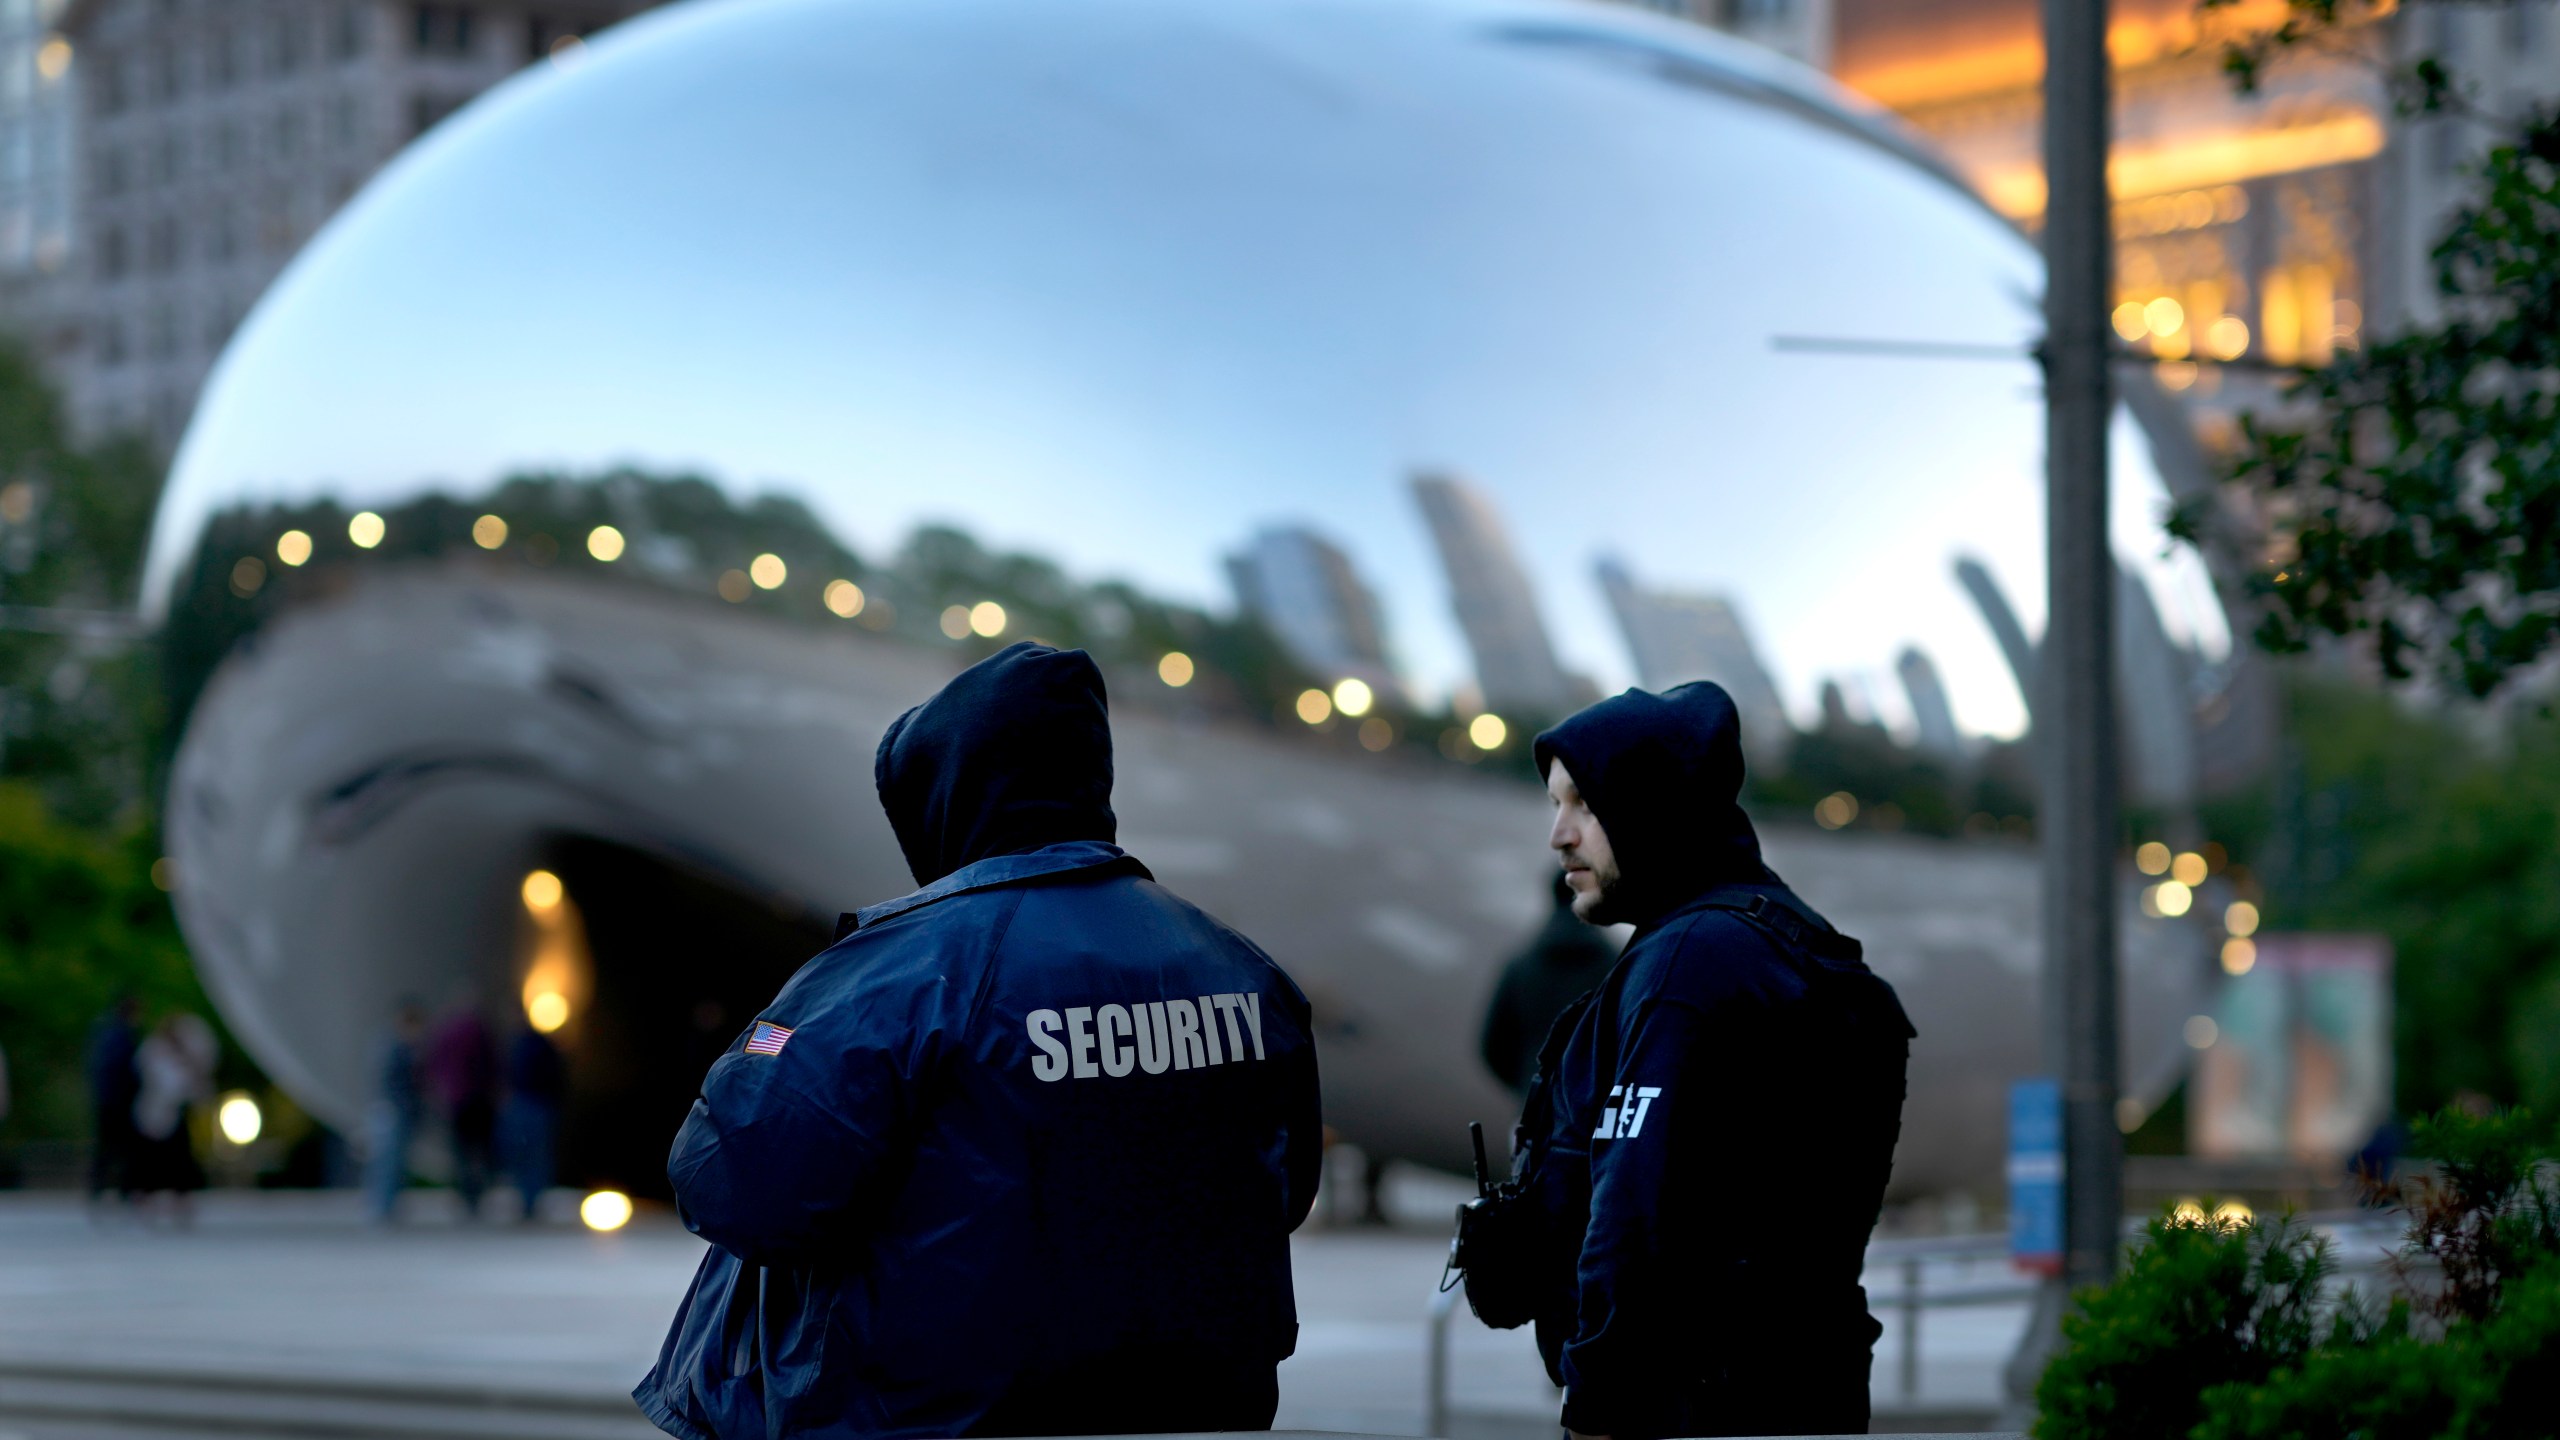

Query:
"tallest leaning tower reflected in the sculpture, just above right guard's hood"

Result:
[[1413, 474, 1592, 717]]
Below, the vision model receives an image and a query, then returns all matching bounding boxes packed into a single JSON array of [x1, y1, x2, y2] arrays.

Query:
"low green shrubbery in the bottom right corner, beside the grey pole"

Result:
[[2035, 1109, 2560, 1440]]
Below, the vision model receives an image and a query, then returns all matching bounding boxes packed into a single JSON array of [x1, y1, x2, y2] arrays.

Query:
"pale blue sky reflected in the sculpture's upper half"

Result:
[[154, 0, 2222, 735]]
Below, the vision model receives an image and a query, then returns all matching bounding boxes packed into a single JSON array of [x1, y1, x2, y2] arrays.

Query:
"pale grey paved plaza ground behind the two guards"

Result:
[[0, 1176, 2022, 1440]]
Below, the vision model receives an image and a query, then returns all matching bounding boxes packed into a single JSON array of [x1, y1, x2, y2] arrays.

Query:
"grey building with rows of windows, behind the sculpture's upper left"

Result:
[[30, 0, 643, 448]]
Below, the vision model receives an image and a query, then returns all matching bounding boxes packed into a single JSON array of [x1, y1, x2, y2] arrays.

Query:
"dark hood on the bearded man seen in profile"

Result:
[[1536, 679, 1777, 925]]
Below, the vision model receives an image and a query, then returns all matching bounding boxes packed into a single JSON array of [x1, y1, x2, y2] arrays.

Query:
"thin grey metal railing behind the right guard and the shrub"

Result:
[[1423, 1212, 2401, 1435]]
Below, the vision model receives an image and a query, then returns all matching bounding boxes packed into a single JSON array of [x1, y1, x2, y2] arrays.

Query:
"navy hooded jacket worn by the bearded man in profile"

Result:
[[1516, 682, 1912, 1440]]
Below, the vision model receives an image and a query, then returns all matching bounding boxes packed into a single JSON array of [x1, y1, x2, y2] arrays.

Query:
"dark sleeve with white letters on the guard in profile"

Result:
[[1562, 983, 1723, 1435]]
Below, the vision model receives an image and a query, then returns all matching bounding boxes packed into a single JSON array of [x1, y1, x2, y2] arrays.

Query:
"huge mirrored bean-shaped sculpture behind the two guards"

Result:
[[148, 0, 2227, 1191]]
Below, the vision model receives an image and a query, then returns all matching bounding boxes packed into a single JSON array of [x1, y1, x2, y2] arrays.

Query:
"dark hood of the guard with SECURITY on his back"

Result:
[[870, 641, 1119, 884]]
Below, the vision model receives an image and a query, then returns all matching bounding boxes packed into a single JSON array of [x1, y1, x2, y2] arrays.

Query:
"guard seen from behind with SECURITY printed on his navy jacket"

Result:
[[635, 643, 1324, 1440]]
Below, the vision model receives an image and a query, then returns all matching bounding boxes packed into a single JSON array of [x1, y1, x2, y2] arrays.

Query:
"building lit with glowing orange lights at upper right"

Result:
[[1830, 0, 2560, 425]]
